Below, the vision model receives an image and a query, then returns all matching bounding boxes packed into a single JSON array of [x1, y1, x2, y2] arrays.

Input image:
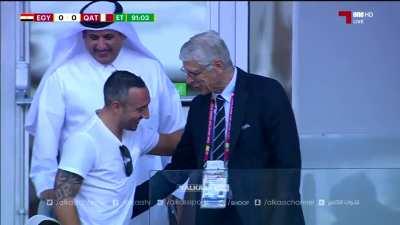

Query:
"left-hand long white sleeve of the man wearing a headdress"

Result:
[[30, 74, 65, 197]]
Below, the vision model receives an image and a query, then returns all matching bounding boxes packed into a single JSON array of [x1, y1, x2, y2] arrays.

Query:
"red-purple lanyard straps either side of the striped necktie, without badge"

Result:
[[204, 93, 235, 162]]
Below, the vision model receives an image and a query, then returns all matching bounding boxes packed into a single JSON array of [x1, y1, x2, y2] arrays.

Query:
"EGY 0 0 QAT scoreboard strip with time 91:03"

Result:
[[20, 13, 156, 23]]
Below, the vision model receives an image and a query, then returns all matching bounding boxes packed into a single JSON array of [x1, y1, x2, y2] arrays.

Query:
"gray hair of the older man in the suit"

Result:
[[179, 30, 233, 67]]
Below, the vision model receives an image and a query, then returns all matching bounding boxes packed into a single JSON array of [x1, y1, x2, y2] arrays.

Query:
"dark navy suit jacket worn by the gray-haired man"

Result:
[[133, 68, 304, 225]]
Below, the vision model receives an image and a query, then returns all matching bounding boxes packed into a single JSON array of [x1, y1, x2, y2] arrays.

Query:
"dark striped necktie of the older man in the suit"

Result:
[[211, 95, 225, 160]]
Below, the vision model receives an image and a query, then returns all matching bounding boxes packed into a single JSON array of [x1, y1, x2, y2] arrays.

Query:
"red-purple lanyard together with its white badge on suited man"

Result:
[[200, 94, 234, 209]]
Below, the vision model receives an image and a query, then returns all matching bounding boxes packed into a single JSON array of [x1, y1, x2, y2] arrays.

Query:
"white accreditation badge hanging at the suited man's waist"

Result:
[[200, 160, 229, 209]]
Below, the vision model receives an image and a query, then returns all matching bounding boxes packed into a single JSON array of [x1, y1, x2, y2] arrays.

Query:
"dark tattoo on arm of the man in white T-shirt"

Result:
[[54, 169, 83, 202]]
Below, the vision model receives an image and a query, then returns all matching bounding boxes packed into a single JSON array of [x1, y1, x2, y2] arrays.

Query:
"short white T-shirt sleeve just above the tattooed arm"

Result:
[[58, 133, 97, 178]]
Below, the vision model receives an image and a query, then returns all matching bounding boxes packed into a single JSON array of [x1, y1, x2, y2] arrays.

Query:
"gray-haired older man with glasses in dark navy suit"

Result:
[[133, 31, 304, 225]]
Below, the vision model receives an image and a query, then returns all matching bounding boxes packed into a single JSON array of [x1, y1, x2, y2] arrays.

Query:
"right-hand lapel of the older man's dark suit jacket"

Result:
[[230, 68, 248, 154]]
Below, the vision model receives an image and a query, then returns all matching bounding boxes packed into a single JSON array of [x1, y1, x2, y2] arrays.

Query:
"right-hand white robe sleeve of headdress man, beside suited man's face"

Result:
[[158, 62, 186, 134]]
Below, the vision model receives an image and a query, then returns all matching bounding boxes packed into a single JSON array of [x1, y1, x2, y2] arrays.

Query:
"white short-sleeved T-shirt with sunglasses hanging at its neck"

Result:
[[58, 114, 159, 225]]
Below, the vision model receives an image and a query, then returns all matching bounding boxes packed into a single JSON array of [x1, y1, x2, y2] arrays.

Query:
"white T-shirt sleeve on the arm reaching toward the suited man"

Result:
[[135, 126, 160, 154]]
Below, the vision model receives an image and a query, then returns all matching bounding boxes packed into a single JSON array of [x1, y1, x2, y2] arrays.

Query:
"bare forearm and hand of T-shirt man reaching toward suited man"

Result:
[[149, 130, 183, 156]]
